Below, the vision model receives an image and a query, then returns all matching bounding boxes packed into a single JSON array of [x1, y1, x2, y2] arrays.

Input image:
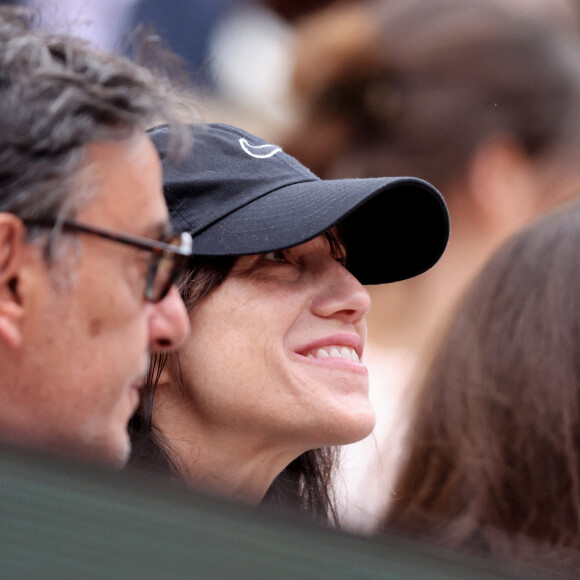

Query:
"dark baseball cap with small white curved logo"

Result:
[[149, 123, 449, 284]]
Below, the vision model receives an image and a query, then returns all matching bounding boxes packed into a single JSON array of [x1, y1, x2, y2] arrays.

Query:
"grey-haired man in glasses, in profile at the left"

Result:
[[0, 8, 191, 467]]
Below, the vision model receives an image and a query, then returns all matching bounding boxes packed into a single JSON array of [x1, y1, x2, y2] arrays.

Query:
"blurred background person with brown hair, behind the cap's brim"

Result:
[[280, 0, 580, 529]]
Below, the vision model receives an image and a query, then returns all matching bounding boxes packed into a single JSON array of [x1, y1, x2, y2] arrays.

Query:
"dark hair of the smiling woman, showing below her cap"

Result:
[[129, 232, 343, 524]]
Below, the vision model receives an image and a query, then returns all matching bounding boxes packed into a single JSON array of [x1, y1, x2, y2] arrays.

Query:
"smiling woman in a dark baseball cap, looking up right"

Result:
[[132, 124, 449, 521]]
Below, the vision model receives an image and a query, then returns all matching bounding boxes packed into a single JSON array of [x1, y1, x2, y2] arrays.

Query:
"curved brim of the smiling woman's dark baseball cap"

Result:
[[188, 177, 449, 284]]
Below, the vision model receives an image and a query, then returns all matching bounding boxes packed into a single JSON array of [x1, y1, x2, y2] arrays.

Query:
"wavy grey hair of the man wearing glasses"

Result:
[[0, 7, 190, 224]]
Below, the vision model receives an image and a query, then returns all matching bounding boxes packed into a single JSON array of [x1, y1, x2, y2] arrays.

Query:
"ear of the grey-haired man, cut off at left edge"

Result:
[[0, 212, 25, 348]]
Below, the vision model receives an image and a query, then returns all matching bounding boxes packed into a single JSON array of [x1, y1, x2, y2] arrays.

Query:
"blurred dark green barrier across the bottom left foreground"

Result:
[[0, 448, 552, 580]]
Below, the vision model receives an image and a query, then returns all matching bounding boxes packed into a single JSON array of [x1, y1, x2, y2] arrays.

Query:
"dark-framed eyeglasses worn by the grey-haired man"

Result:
[[23, 219, 193, 302]]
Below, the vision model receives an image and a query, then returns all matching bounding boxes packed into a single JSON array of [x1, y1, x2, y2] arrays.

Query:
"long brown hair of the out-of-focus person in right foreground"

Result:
[[383, 203, 580, 572]]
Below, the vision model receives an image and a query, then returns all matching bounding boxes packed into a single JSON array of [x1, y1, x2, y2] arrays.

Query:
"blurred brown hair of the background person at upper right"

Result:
[[286, 0, 580, 187]]
